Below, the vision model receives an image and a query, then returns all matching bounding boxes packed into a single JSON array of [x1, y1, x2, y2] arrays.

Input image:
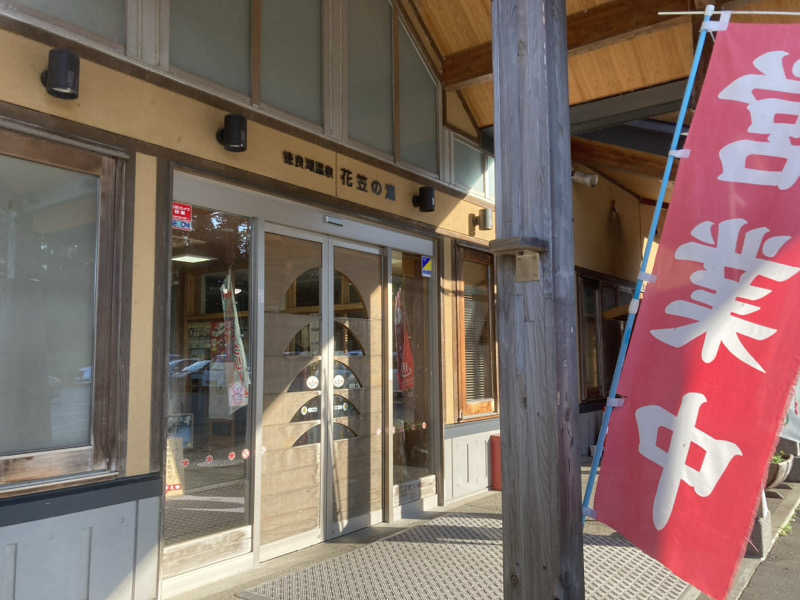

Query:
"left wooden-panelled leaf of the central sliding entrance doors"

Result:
[[259, 233, 325, 548]]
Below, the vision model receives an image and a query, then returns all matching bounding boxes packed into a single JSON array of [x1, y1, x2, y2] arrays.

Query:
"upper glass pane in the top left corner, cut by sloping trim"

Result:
[[13, 0, 125, 45]]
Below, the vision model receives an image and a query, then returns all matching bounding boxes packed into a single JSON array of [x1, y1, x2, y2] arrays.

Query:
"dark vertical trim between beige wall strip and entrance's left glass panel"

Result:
[[150, 158, 172, 472]]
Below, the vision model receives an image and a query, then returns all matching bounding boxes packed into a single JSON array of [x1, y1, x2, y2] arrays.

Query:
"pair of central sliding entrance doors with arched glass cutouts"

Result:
[[260, 226, 383, 559]]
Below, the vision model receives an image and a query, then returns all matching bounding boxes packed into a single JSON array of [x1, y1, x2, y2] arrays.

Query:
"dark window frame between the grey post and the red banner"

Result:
[[575, 267, 635, 413]]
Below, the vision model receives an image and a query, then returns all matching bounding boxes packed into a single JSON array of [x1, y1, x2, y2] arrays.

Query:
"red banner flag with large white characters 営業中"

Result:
[[595, 24, 800, 598]]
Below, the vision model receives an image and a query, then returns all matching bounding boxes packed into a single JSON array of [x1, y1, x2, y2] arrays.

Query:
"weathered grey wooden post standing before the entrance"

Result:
[[492, 0, 584, 600]]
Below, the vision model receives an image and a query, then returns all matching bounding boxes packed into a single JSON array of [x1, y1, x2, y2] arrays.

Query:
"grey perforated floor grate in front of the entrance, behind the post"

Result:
[[238, 513, 688, 600]]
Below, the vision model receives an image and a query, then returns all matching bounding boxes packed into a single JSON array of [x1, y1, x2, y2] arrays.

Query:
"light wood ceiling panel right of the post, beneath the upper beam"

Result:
[[569, 19, 693, 104]]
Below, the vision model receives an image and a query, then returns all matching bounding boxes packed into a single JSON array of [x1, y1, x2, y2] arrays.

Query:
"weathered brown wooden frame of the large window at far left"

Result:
[[0, 128, 127, 498]]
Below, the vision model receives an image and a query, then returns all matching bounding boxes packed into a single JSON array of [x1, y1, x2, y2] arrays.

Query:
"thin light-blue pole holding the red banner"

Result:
[[583, 4, 715, 523]]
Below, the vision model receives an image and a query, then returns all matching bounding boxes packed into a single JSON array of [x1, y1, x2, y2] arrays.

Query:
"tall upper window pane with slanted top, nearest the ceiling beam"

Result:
[[398, 26, 437, 173]]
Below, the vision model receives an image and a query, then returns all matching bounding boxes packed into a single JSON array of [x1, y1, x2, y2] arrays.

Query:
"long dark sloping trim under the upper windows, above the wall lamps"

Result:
[[0, 15, 476, 198]]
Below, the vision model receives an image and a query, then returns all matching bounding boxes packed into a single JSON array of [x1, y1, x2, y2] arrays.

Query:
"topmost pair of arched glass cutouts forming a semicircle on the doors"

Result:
[[283, 267, 367, 319]]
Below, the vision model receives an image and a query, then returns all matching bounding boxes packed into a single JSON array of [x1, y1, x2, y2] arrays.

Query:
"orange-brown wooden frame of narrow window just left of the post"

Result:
[[453, 243, 500, 422]]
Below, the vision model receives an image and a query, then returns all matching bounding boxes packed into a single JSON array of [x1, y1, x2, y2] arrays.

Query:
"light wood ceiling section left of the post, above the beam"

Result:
[[413, 0, 492, 56]]
